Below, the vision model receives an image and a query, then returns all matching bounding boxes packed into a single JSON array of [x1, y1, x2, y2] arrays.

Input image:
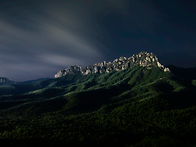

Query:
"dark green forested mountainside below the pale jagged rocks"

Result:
[[0, 52, 196, 147]]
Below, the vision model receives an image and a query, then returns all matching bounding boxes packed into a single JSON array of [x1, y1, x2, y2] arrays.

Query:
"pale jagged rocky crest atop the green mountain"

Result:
[[55, 52, 170, 78]]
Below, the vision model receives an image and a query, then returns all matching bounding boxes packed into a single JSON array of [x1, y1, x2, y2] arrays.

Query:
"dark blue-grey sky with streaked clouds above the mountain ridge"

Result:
[[0, 0, 196, 82]]
